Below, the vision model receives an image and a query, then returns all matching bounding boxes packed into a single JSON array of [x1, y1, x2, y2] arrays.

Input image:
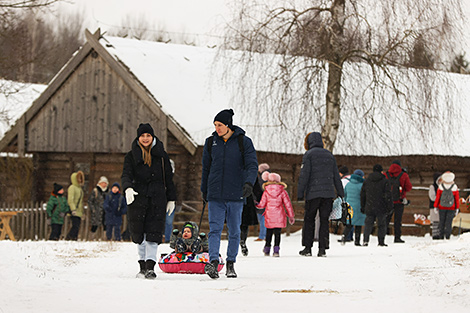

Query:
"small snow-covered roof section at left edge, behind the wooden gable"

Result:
[[0, 80, 47, 139]]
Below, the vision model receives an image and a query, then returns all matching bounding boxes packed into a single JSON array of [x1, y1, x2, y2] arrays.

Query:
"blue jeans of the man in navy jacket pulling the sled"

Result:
[[209, 201, 243, 262]]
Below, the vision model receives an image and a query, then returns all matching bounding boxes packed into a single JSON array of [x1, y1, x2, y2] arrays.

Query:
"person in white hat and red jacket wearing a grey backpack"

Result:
[[434, 172, 460, 239]]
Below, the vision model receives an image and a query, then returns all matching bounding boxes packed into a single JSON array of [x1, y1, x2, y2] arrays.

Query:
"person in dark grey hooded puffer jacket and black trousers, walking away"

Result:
[[297, 132, 344, 257]]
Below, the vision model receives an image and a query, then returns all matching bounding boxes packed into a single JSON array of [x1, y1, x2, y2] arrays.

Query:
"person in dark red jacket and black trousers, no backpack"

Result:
[[386, 160, 412, 243]]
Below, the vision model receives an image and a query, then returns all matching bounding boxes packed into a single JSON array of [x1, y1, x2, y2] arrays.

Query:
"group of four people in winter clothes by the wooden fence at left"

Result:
[[46, 171, 127, 241]]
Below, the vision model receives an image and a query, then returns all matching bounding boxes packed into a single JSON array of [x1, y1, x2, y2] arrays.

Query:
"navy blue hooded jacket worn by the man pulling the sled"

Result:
[[201, 126, 258, 201]]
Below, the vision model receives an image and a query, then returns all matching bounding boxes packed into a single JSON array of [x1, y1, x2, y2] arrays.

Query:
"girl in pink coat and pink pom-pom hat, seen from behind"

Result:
[[257, 172, 295, 257]]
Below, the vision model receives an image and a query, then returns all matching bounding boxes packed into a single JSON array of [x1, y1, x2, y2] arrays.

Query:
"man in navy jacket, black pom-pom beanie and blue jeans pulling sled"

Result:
[[201, 109, 258, 279]]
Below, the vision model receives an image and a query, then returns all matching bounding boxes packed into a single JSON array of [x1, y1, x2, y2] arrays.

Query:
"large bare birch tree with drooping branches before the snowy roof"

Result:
[[221, 0, 462, 152]]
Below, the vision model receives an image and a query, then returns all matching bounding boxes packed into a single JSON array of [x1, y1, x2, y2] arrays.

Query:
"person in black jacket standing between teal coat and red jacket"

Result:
[[361, 164, 393, 247]]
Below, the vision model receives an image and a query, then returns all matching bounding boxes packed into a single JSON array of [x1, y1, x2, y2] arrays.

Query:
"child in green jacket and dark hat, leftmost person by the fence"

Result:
[[46, 183, 70, 240]]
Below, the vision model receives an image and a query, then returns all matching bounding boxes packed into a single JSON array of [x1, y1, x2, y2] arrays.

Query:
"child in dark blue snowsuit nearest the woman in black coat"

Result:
[[103, 183, 127, 241]]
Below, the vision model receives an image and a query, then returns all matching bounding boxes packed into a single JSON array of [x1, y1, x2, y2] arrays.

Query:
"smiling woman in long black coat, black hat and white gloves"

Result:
[[121, 124, 176, 279]]
